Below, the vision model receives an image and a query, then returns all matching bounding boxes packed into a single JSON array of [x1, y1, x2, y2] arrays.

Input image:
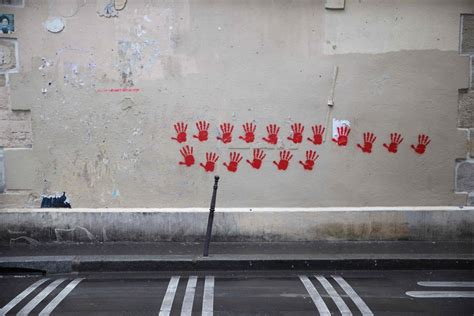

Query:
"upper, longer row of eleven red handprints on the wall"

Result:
[[171, 121, 431, 155]]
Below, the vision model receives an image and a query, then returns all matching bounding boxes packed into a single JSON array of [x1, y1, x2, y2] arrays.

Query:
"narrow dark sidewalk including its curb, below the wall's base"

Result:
[[0, 241, 474, 273]]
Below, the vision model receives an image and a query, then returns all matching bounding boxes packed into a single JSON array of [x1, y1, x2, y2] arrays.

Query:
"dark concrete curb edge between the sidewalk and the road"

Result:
[[0, 255, 474, 274]]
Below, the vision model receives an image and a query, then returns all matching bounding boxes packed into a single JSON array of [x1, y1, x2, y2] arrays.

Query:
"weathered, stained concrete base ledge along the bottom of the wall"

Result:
[[0, 207, 474, 244]]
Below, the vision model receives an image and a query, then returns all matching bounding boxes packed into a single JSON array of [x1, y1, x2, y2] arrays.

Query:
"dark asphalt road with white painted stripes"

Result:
[[0, 270, 474, 316]]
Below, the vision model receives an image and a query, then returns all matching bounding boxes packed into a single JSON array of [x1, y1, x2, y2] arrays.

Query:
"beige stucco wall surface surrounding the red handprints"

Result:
[[0, 0, 474, 207]]
